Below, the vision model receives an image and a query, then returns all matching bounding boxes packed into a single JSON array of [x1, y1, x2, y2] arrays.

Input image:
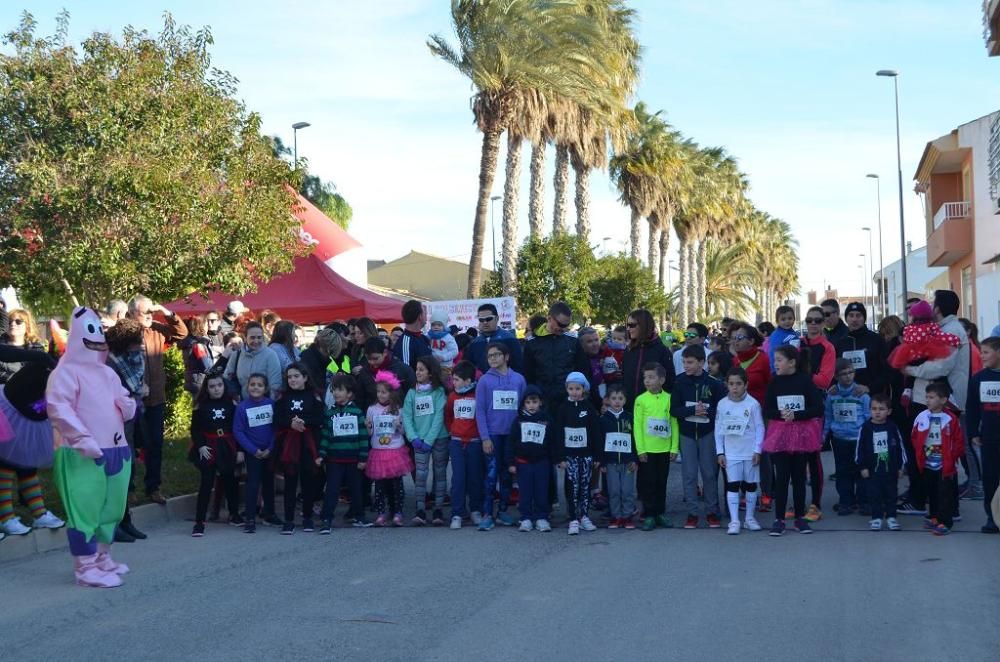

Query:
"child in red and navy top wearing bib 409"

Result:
[[444, 361, 484, 529]]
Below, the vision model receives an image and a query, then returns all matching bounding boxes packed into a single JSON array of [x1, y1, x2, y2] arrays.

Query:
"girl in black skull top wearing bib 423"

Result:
[[274, 362, 326, 536]]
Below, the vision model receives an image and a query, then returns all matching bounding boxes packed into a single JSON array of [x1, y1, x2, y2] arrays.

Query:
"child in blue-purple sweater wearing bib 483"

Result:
[[233, 372, 284, 533]]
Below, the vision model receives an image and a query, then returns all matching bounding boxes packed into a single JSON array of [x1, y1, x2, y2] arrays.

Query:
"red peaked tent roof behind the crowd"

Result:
[[164, 253, 403, 324]]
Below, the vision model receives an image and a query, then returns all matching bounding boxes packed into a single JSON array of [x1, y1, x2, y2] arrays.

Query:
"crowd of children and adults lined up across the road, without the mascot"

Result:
[[0, 290, 1000, 542]]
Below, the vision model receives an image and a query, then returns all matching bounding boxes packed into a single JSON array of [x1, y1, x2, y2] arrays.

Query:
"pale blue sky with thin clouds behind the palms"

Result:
[[0, 0, 1000, 304]]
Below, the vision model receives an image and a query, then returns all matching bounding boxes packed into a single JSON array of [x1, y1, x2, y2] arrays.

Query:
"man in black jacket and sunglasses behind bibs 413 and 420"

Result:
[[524, 301, 578, 412]]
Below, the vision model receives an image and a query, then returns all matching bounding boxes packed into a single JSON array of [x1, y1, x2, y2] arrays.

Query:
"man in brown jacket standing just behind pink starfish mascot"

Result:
[[128, 294, 187, 505]]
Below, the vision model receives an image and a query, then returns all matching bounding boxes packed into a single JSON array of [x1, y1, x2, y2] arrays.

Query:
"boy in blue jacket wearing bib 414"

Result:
[[823, 359, 871, 515]]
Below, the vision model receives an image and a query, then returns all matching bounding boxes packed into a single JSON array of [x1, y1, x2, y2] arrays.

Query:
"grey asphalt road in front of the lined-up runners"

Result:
[[0, 458, 1000, 662]]
